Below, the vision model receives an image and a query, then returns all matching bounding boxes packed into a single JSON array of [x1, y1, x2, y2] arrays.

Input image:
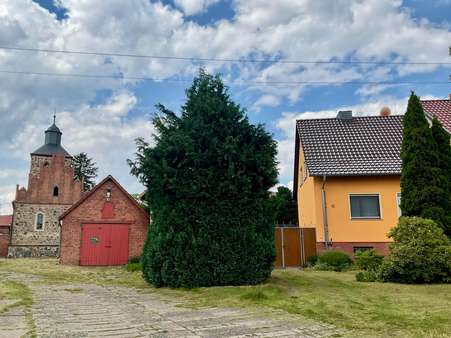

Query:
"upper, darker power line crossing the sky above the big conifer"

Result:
[[0, 46, 451, 66]]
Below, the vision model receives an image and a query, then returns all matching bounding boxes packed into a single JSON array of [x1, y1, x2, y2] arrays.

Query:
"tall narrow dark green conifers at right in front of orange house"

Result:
[[401, 93, 450, 235]]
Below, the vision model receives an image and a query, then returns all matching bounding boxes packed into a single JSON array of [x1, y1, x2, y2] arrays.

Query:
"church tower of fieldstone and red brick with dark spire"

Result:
[[8, 117, 83, 257]]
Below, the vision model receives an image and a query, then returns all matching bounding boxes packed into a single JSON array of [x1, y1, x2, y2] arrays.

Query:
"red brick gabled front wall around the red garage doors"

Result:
[[60, 180, 149, 265]]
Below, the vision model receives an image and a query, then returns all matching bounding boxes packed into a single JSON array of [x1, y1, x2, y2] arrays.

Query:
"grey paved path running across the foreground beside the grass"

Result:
[[0, 271, 340, 338]]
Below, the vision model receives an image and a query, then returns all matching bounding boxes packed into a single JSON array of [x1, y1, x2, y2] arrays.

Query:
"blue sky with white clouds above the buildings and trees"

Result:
[[0, 0, 451, 214]]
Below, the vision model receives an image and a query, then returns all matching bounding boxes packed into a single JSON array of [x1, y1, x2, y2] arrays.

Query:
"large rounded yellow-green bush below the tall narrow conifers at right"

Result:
[[380, 217, 451, 283]]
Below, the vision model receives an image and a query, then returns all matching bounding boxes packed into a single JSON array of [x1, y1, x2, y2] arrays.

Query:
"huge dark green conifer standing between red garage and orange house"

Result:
[[129, 71, 277, 287]]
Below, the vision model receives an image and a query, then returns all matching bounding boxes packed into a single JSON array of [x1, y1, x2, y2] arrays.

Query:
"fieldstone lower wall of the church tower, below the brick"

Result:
[[8, 202, 70, 257]]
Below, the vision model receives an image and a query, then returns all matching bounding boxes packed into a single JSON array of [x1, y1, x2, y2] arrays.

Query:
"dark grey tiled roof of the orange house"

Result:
[[297, 115, 402, 176]]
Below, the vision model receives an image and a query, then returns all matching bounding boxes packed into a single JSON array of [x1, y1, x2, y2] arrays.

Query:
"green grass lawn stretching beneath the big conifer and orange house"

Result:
[[0, 259, 451, 337]]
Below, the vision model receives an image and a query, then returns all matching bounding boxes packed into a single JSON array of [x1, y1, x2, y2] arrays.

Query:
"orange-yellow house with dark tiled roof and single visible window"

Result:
[[293, 111, 402, 254]]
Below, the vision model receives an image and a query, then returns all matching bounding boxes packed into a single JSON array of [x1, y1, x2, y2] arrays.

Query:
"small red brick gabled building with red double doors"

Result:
[[60, 176, 149, 265]]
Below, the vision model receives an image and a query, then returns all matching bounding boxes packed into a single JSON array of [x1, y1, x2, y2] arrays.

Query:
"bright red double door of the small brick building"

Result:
[[80, 224, 128, 265]]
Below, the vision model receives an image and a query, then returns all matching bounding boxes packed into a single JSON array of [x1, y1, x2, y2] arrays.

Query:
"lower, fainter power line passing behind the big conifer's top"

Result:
[[0, 70, 451, 86]]
